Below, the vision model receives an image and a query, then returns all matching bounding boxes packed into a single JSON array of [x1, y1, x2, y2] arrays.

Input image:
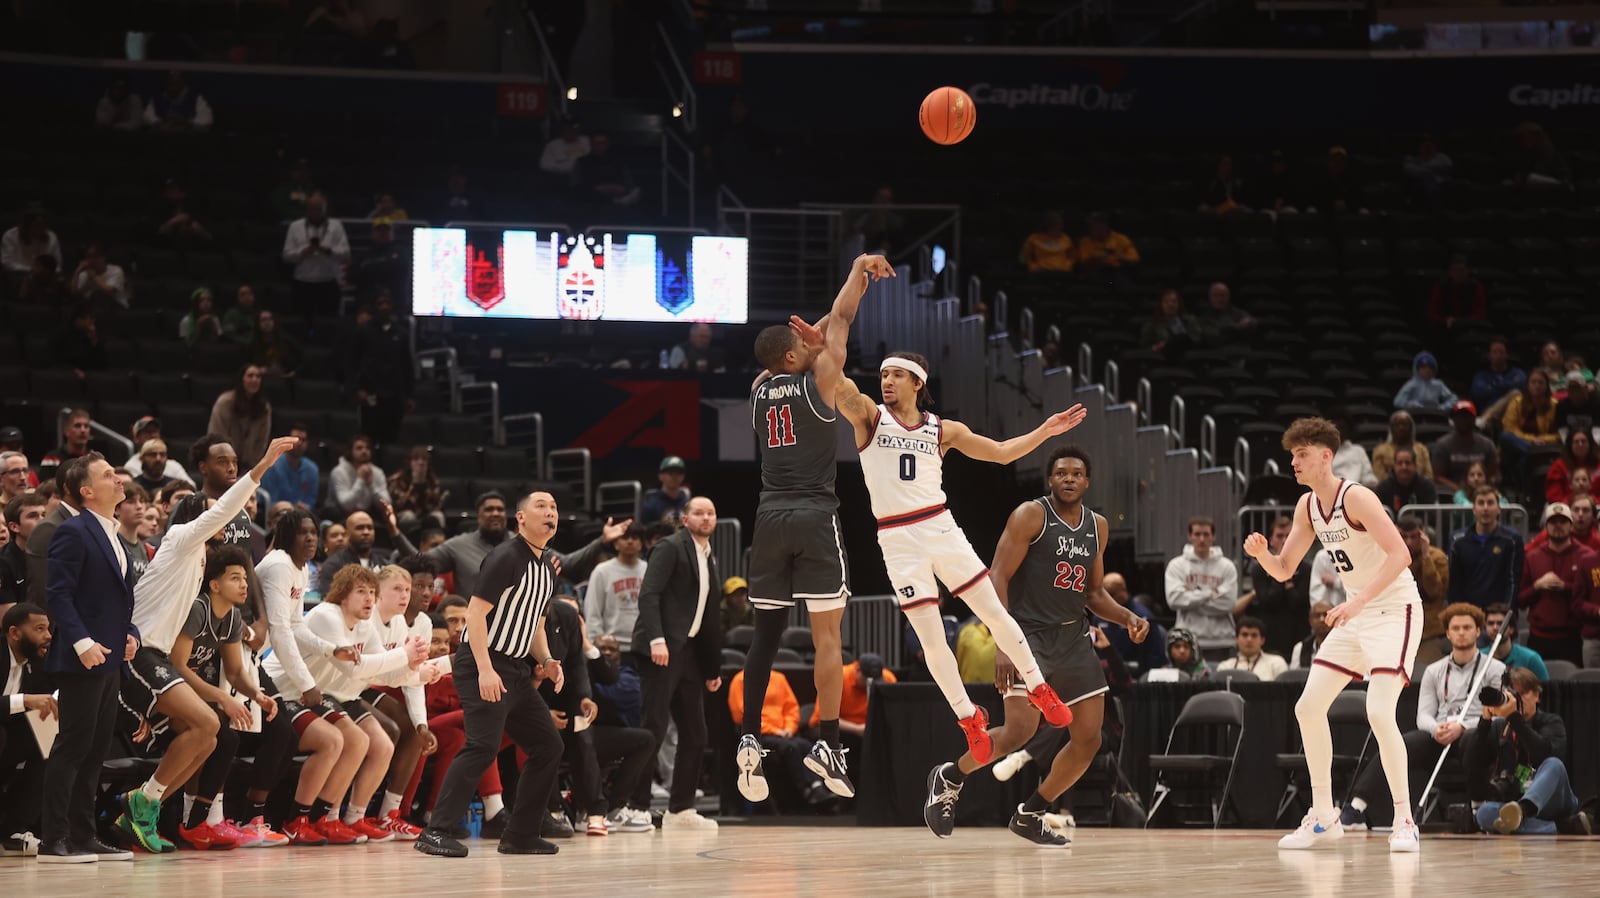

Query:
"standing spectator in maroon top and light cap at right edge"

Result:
[[1517, 503, 1600, 664]]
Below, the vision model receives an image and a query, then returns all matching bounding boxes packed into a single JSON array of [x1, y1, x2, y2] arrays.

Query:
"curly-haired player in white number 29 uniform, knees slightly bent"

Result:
[[1245, 418, 1422, 852]]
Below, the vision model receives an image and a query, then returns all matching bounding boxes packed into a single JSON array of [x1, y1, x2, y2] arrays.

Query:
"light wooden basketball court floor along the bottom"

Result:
[[0, 824, 1600, 898]]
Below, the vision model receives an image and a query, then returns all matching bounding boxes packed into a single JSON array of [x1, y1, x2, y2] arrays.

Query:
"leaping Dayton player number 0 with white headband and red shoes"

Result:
[[812, 342, 1088, 764]]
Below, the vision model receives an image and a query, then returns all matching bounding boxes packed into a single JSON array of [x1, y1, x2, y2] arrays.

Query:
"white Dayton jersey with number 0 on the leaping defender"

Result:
[[856, 405, 944, 527]]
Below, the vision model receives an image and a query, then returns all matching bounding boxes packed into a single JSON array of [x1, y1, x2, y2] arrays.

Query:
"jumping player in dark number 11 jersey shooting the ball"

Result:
[[736, 249, 894, 802]]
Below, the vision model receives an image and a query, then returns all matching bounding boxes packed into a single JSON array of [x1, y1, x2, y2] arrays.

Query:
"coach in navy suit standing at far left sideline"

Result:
[[38, 453, 139, 863]]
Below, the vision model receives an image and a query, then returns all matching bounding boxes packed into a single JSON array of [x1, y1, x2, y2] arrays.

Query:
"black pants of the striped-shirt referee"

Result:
[[430, 645, 562, 842]]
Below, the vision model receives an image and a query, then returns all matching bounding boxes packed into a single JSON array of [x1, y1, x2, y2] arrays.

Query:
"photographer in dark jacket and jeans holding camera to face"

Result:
[[1467, 667, 1592, 836]]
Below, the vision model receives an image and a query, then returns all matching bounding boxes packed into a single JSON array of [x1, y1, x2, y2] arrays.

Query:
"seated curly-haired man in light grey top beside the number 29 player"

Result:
[[1339, 603, 1506, 826]]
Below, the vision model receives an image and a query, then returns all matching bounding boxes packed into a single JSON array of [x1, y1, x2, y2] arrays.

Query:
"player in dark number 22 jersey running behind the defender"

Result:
[[923, 447, 1150, 848]]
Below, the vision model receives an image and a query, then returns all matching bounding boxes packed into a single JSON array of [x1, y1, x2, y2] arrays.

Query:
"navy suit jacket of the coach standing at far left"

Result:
[[45, 511, 139, 677]]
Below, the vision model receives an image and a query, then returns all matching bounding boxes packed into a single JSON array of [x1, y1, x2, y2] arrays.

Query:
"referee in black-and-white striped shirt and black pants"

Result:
[[416, 491, 563, 858]]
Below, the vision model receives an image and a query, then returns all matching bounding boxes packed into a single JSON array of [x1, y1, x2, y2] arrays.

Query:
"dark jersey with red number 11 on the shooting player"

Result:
[[750, 371, 838, 511]]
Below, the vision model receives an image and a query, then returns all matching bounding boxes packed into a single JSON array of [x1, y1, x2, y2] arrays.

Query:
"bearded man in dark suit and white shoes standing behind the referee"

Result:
[[634, 496, 722, 829]]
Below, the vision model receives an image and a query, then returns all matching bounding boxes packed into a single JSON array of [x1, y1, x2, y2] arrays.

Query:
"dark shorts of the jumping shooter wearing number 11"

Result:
[[750, 509, 850, 611]]
